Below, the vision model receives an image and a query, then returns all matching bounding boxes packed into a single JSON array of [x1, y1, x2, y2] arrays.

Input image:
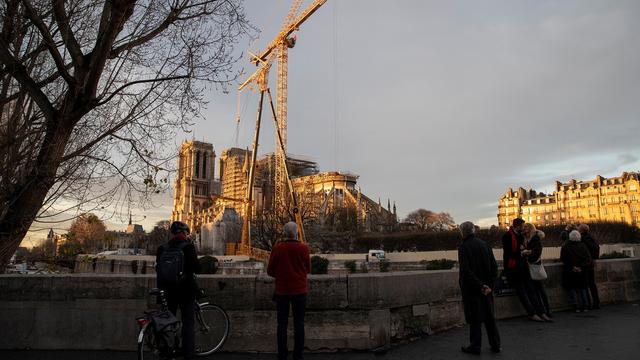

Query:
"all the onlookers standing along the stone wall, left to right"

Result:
[[157, 218, 600, 360]]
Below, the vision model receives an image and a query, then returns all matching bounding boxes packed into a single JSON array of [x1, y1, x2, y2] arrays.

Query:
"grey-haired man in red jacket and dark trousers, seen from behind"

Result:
[[267, 221, 311, 360]]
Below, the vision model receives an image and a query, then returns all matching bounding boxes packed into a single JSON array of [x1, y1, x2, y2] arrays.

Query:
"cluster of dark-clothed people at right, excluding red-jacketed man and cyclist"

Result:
[[458, 218, 600, 354]]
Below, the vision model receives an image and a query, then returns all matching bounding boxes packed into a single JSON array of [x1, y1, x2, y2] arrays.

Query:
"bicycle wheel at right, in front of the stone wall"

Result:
[[195, 304, 231, 356]]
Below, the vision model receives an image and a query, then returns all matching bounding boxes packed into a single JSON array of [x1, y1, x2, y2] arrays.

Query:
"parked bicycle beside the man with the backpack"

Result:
[[136, 288, 231, 360]]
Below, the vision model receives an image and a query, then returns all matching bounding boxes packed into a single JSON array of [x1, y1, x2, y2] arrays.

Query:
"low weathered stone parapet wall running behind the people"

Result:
[[0, 259, 640, 352]]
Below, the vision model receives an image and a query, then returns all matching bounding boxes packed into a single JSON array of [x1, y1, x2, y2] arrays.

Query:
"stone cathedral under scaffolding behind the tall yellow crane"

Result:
[[171, 141, 398, 255]]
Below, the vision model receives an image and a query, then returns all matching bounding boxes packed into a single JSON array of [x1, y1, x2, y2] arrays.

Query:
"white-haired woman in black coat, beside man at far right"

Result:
[[560, 230, 591, 312]]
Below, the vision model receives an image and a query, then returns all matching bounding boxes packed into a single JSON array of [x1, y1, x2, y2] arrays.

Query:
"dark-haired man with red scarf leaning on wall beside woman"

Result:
[[502, 218, 544, 322]]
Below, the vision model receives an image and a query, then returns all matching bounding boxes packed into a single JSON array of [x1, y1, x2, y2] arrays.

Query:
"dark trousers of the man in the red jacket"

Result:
[[273, 294, 307, 360]]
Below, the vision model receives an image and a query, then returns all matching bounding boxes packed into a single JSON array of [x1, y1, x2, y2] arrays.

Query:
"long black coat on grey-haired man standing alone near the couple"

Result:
[[458, 235, 498, 323]]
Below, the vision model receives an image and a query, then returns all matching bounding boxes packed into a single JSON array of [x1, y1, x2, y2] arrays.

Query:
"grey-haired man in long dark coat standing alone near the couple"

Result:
[[458, 221, 501, 354]]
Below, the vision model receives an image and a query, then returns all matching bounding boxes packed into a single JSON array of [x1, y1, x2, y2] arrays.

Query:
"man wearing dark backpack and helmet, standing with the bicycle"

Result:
[[156, 221, 200, 359]]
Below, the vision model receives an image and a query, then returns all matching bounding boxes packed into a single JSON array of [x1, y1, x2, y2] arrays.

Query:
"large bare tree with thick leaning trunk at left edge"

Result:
[[0, 0, 253, 272]]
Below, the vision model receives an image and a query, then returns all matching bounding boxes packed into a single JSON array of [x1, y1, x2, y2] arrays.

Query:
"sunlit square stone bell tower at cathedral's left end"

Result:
[[171, 140, 220, 225]]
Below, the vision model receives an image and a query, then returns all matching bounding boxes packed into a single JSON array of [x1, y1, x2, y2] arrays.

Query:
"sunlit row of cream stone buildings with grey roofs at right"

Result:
[[498, 172, 640, 228]]
